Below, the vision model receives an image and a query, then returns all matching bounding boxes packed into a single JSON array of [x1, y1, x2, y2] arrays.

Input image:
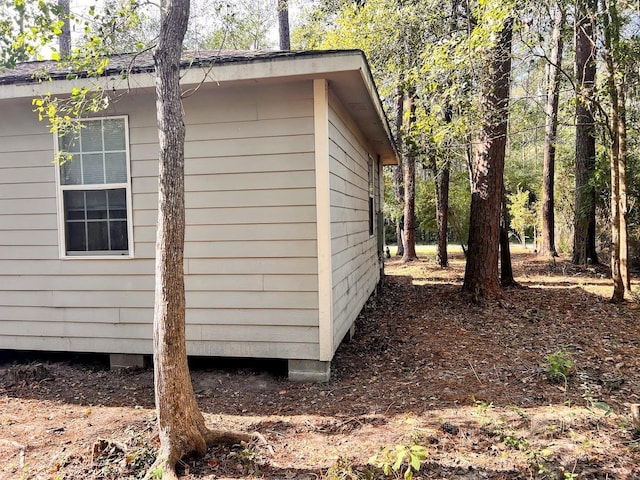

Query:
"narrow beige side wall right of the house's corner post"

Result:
[[329, 98, 380, 346]]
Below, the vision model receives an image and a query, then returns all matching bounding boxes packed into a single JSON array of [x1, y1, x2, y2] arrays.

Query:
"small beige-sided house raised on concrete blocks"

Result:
[[0, 47, 397, 380]]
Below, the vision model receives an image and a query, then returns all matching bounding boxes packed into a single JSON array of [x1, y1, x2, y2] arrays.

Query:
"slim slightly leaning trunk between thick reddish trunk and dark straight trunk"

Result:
[[538, 2, 564, 257]]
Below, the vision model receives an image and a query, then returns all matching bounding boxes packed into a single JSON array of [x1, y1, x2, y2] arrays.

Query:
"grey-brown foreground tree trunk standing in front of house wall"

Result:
[[147, 0, 250, 480]]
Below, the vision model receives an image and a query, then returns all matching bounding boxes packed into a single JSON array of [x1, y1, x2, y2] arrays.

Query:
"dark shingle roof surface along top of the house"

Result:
[[0, 50, 356, 85]]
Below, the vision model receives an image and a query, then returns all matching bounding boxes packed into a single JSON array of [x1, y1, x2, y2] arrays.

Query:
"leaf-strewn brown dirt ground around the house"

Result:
[[0, 255, 640, 480]]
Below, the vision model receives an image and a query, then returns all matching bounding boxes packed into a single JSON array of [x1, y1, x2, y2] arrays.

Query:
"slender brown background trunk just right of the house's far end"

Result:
[[402, 90, 418, 262]]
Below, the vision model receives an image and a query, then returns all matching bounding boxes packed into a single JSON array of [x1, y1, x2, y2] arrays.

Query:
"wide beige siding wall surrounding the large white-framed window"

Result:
[[0, 81, 318, 358]]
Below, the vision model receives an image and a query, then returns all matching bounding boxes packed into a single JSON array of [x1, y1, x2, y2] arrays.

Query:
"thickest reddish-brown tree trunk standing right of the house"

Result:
[[462, 19, 512, 298]]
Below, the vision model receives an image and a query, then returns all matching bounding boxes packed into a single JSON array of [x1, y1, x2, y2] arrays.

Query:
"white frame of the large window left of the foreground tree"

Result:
[[53, 115, 134, 260]]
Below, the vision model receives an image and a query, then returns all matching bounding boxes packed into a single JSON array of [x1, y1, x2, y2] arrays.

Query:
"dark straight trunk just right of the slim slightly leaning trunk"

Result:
[[572, 0, 598, 265]]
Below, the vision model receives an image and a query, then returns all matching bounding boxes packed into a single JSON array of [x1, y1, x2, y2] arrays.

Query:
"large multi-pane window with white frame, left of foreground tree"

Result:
[[58, 117, 131, 256]]
